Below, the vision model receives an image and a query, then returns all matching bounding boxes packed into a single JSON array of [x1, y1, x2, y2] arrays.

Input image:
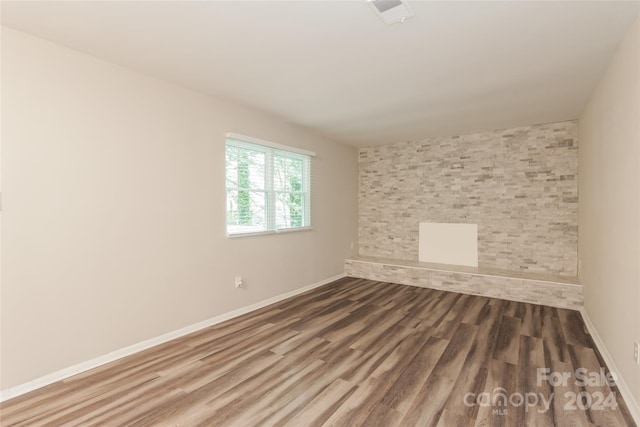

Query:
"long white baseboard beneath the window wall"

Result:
[[0, 273, 346, 402]]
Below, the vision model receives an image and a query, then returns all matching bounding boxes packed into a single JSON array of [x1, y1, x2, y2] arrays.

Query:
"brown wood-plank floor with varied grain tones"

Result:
[[0, 278, 635, 427]]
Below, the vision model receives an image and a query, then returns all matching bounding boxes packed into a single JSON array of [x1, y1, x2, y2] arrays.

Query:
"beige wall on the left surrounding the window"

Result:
[[0, 29, 358, 389]]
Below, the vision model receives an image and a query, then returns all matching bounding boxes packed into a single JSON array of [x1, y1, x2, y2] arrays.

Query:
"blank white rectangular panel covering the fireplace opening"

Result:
[[418, 222, 478, 267]]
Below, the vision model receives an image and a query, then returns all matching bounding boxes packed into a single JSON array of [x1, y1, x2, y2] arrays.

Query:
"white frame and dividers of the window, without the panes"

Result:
[[225, 132, 316, 238]]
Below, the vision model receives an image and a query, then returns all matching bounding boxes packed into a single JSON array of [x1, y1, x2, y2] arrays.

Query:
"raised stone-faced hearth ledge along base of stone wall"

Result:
[[345, 256, 582, 310]]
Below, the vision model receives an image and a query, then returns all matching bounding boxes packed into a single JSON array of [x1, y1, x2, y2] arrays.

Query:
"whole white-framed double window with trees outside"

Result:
[[225, 133, 315, 236]]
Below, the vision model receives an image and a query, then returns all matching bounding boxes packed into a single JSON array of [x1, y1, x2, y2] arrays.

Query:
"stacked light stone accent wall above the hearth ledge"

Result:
[[359, 121, 578, 276]]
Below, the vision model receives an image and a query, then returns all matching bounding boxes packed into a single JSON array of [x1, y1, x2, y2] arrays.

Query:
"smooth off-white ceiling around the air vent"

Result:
[[1, 0, 640, 146]]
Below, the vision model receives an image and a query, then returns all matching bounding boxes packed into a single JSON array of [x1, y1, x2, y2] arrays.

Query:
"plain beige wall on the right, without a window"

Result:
[[578, 21, 640, 408]]
